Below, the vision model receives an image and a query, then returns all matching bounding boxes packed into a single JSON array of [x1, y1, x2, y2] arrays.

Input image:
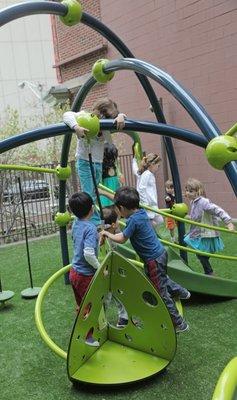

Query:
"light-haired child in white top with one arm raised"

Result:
[[133, 153, 163, 226]]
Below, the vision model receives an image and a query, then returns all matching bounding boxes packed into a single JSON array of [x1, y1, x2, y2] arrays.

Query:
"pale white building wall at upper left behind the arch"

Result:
[[0, 0, 57, 119]]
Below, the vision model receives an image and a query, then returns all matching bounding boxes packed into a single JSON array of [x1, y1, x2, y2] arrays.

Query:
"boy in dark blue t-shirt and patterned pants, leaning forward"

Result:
[[101, 186, 190, 333]]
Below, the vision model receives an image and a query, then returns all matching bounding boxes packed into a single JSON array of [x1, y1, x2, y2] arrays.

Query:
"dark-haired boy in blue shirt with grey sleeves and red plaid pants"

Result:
[[69, 192, 100, 346]]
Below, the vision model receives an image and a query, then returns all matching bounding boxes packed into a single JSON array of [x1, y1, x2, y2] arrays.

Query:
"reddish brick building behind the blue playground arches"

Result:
[[51, 0, 237, 217]]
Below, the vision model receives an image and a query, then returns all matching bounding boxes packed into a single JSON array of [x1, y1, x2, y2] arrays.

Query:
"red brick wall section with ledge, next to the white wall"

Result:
[[52, 0, 107, 106]]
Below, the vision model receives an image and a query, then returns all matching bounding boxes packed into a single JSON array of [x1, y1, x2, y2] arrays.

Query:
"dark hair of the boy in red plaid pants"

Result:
[[68, 192, 93, 218]]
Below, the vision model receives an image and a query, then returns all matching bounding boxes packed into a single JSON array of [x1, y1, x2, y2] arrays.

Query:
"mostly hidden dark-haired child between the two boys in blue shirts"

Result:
[[103, 207, 128, 328]]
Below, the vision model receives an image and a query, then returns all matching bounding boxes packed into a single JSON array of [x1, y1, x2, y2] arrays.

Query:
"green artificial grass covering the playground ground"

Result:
[[0, 235, 237, 400]]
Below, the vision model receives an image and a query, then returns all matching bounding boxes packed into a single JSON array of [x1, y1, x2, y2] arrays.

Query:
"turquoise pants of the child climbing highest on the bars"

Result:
[[77, 160, 102, 225]]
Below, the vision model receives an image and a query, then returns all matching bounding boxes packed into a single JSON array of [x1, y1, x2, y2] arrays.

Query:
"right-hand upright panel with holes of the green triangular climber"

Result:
[[108, 253, 176, 360]]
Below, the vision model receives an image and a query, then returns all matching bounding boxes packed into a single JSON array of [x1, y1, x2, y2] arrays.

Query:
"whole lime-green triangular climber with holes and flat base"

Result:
[[67, 249, 176, 384]]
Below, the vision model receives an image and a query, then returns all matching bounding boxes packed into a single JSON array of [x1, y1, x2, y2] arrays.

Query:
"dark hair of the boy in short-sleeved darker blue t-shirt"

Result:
[[114, 186, 140, 210]]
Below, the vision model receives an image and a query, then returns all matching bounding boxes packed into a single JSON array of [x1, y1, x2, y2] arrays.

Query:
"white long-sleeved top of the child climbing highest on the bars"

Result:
[[63, 111, 112, 163]]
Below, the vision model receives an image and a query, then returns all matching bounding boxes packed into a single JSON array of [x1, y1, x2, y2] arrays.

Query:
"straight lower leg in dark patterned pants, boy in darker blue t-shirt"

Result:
[[145, 251, 184, 327]]
